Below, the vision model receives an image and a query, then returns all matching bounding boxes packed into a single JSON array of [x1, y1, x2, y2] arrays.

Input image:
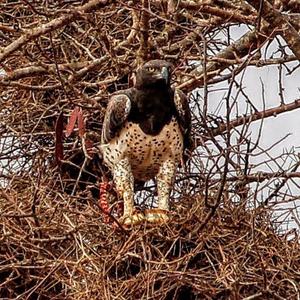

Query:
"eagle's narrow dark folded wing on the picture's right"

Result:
[[174, 89, 194, 151]]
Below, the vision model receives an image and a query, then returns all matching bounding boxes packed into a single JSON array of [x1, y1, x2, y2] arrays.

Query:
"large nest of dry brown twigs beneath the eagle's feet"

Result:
[[0, 178, 300, 299]]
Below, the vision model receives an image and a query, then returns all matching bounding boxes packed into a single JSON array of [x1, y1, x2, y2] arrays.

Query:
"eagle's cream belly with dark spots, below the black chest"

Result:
[[101, 117, 183, 180]]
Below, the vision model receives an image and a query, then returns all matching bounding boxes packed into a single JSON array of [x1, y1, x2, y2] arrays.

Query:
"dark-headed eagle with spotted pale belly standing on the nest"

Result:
[[101, 60, 191, 226]]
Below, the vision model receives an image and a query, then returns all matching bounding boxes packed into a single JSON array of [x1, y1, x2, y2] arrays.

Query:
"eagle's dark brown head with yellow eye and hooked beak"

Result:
[[135, 59, 172, 88]]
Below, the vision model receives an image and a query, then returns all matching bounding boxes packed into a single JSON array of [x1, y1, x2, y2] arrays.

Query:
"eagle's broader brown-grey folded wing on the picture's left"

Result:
[[101, 93, 131, 144]]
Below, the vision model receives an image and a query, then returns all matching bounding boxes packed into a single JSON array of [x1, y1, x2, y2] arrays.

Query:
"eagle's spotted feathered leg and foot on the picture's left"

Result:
[[113, 158, 142, 226]]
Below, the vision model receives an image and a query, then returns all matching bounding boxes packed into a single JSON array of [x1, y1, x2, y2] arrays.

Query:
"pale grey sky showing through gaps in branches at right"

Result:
[[202, 26, 300, 229]]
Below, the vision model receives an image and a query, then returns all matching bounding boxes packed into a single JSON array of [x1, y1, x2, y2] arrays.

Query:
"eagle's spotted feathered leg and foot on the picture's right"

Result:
[[146, 159, 176, 223]]
